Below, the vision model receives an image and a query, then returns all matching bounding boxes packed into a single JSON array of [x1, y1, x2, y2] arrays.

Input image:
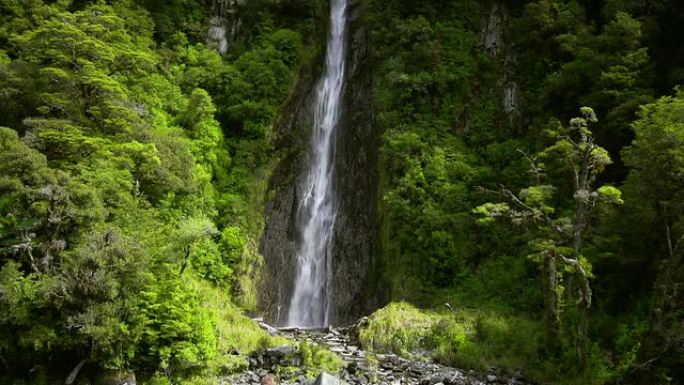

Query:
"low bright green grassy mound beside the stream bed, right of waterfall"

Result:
[[359, 303, 598, 384]]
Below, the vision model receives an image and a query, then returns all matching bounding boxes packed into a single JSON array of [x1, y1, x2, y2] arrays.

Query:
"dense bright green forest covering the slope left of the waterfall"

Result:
[[0, 0, 324, 381]]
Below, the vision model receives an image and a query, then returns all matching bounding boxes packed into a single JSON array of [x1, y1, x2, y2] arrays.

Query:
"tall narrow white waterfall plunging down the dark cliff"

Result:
[[288, 0, 347, 327]]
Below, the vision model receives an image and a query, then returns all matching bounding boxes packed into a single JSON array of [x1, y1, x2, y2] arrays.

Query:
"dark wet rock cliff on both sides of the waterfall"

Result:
[[260, 0, 379, 324]]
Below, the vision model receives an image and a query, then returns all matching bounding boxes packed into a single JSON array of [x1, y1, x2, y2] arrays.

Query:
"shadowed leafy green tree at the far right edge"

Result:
[[621, 89, 684, 383]]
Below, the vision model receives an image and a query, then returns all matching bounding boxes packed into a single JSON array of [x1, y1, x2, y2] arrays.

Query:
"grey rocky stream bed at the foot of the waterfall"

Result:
[[223, 323, 527, 385]]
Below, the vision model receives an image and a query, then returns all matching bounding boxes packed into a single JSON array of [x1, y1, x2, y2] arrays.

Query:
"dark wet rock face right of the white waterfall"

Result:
[[330, 0, 379, 325]]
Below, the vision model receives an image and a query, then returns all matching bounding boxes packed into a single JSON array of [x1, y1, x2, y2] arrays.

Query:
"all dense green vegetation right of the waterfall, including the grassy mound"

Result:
[[362, 0, 684, 384]]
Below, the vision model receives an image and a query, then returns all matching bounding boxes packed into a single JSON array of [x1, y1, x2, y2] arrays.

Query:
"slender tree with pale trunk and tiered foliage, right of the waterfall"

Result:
[[473, 107, 622, 372]]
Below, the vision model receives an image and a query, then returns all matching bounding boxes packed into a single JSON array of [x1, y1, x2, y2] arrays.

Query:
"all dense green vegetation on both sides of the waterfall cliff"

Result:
[[0, 0, 684, 384]]
